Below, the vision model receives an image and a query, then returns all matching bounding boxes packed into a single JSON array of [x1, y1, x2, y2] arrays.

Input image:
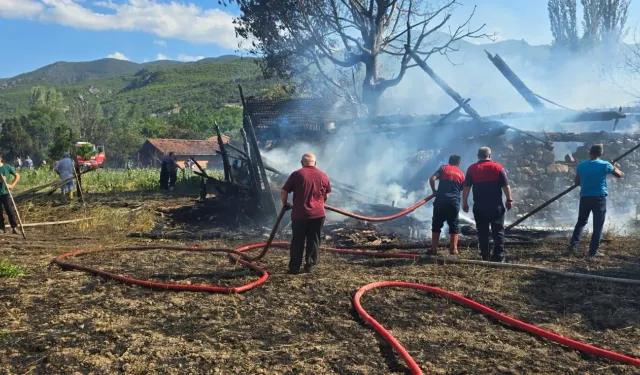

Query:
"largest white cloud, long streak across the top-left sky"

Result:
[[0, 0, 238, 49]]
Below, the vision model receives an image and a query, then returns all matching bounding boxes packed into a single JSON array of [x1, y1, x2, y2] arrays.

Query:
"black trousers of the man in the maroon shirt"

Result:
[[289, 217, 324, 273]]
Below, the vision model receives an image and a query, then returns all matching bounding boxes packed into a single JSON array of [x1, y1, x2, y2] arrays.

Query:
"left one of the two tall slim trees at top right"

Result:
[[547, 0, 579, 50]]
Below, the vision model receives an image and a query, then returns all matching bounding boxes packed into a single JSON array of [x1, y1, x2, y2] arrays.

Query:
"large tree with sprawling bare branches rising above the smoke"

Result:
[[229, 0, 486, 116]]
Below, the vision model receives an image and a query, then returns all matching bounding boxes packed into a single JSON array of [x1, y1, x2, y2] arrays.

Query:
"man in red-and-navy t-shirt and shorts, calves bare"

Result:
[[429, 155, 464, 255]]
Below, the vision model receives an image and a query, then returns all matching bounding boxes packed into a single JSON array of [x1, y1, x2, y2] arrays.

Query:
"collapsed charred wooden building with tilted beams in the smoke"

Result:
[[201, 50, 640, 226]]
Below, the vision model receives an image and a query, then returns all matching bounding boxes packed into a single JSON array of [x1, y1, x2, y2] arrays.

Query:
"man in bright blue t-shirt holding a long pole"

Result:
[[569, 144, 623, 257]]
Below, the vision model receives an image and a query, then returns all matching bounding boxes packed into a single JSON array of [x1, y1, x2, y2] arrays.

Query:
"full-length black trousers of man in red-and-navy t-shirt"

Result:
[[473, 206, 506, 260]]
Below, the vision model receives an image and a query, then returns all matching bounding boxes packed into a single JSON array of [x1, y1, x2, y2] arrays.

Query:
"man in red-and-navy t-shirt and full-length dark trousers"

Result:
[[462, 147, 513, 263]]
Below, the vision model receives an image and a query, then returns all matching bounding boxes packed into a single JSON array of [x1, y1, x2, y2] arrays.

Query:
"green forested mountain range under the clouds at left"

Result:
[[0, 55, 271, 119]]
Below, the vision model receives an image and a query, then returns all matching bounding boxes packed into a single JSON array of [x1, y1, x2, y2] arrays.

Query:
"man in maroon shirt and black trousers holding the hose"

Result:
[[280, 152, 331, 274]]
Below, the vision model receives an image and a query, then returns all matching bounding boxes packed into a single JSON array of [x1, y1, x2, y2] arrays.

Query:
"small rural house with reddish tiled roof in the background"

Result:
[[136, 136, 229, 169]]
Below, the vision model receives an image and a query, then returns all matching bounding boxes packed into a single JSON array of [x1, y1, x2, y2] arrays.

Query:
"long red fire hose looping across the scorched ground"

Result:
[[53, 195, 640, 375]]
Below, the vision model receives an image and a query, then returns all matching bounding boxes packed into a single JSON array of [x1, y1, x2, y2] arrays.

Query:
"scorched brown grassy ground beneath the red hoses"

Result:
[[0, 197, 640, 374]]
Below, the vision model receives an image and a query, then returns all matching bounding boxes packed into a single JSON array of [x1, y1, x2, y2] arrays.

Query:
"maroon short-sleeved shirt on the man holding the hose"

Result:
[[282, 166, 331, 220]]
